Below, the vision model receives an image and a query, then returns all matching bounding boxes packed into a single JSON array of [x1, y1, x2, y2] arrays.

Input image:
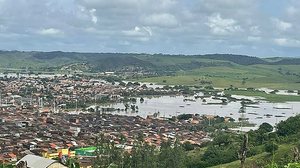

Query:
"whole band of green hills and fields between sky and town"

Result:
[[0, 51, 300, 90]]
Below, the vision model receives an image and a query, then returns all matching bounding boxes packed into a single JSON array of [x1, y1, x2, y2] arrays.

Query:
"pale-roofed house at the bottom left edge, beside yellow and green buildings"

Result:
[[16, 155, 67, 168]]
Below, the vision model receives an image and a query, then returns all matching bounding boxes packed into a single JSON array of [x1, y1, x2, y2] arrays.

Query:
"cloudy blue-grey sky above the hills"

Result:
[[0, 0, 300, 57]]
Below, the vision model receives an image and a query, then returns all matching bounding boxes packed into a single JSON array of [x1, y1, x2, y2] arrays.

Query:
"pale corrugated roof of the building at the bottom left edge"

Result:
[[17, 155, 57, 168]]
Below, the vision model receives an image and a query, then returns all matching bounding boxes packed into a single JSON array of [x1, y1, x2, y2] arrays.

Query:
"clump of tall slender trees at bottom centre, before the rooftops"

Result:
[[94, 134, 187, 168]]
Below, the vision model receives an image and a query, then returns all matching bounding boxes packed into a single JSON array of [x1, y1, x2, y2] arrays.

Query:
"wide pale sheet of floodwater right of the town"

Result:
[[101, 96, 300, 125]]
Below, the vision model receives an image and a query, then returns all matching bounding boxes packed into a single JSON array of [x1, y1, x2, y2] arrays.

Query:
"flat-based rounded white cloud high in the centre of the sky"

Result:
[[144, 13, 178, 27]]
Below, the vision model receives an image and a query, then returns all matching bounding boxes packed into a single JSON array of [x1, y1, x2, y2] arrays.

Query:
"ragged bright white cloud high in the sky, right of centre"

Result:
[[206, 13, 243, 35]]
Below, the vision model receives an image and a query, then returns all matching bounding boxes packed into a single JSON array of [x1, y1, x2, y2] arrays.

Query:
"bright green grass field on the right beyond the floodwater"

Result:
[[140, 65, 300, 90]]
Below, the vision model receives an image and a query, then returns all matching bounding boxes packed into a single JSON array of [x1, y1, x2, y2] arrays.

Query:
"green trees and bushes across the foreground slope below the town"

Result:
[[86, 115, 300, 168]]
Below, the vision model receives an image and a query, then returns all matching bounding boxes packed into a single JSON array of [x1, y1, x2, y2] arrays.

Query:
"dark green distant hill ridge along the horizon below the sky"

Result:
[[0, 51, 300, 71]]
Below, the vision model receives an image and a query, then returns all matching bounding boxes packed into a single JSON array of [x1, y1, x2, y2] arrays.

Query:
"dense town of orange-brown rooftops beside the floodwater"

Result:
[[0, 75, 211, 167]]
